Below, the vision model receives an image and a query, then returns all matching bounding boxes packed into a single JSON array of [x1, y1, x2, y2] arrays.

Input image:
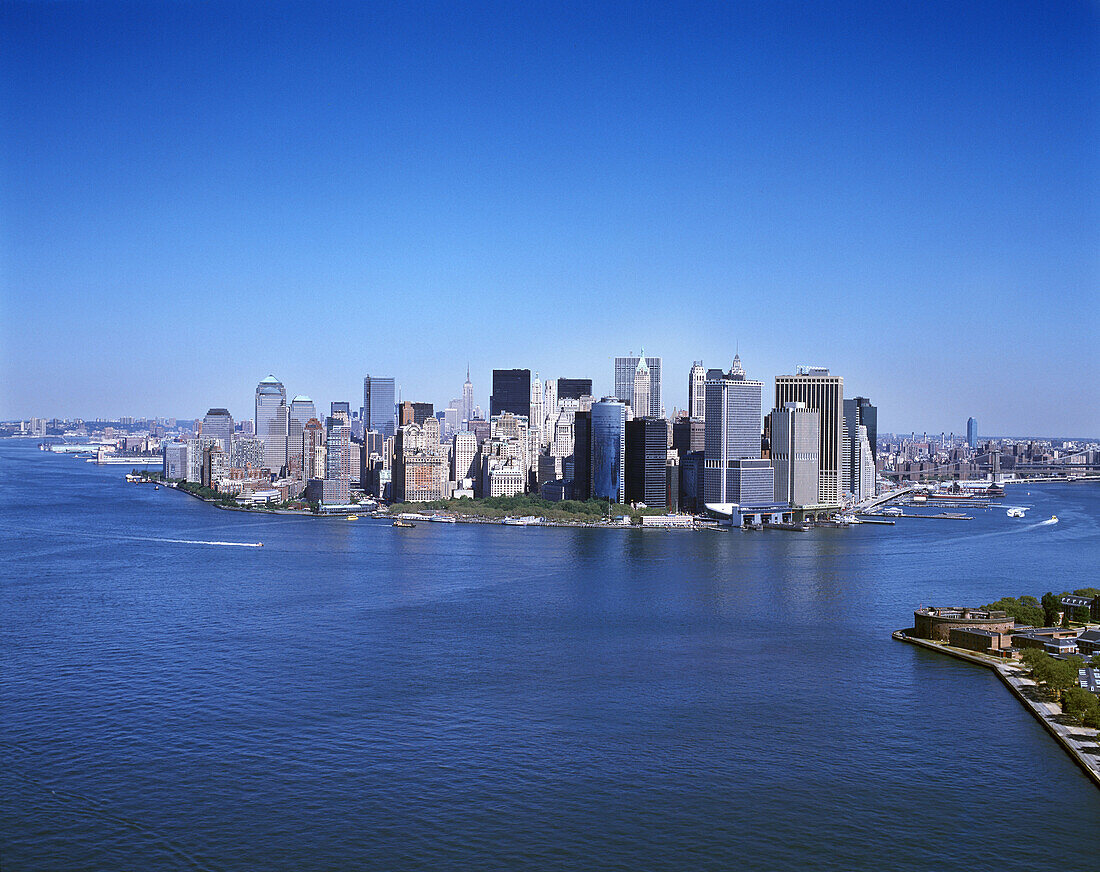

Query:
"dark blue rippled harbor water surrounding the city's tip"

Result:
[[0, 441, 1100, 872]]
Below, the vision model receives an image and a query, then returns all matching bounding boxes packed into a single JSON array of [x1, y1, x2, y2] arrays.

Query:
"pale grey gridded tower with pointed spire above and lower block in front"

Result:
[[703, 355, 774, 506]]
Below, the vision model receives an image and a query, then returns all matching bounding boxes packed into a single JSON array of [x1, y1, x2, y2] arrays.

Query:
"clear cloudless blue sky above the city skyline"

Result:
[[0, 0, 1100, 435]]
